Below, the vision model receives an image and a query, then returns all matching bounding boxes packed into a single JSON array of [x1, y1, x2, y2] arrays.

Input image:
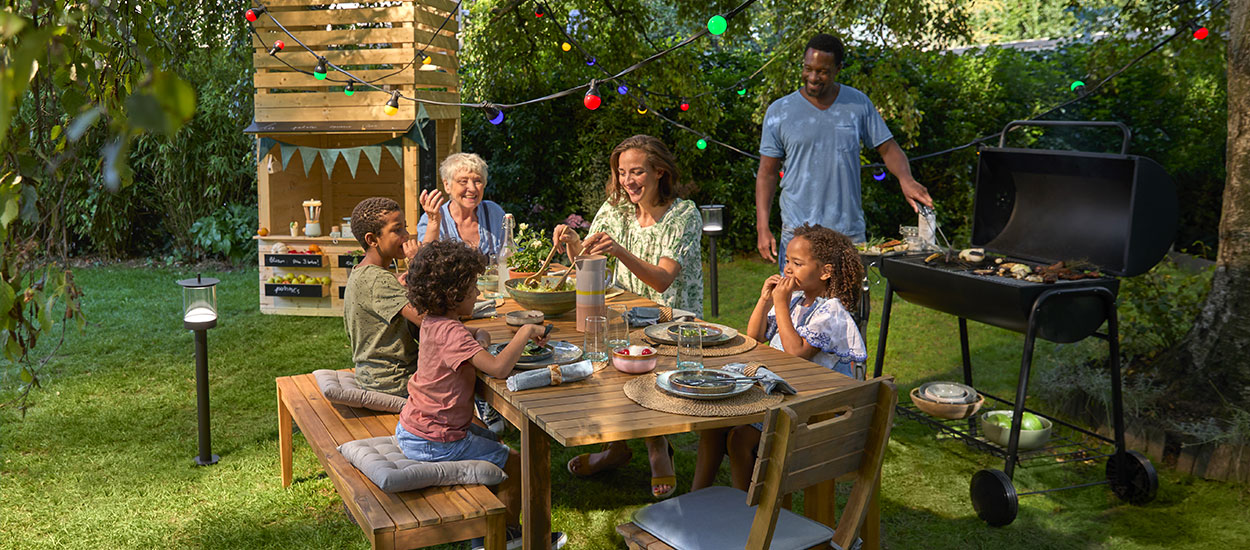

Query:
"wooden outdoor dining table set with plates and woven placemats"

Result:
[[466, 293, 879, 550]]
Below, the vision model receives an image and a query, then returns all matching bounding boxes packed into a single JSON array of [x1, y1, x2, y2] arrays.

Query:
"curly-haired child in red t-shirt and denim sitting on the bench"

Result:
[[395, 240, 568, 548]]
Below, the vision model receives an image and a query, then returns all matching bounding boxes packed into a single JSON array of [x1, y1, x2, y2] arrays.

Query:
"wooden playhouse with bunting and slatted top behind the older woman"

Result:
[[245, 0, 460, 316]]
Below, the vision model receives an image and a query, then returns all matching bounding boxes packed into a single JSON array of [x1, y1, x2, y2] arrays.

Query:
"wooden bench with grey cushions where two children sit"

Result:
[[278, 374, 505, 550]]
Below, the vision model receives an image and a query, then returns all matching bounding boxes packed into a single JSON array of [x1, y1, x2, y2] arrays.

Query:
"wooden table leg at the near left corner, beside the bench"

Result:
[[521, 419, 551, 550]]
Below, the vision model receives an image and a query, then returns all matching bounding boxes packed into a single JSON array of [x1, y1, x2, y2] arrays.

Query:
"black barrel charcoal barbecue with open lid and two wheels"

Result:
[[875, 121, 1178, 526]]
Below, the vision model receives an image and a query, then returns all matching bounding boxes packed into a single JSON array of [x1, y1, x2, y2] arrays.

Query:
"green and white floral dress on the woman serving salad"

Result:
[[590, 199, 703, 318]]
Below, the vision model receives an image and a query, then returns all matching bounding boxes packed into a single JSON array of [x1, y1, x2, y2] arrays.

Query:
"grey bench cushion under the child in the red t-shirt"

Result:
[[339, 435, 508, 493]]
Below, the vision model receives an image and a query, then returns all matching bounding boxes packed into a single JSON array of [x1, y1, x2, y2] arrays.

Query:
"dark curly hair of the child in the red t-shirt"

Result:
[[404, 240, 486, 315]]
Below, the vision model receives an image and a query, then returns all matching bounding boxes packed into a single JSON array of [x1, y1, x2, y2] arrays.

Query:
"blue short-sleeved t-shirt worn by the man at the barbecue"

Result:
[[760, 84, 894, 239]]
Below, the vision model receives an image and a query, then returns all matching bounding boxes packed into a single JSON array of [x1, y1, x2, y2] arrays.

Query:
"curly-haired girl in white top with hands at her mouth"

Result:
[[691, 224, 868, 490]]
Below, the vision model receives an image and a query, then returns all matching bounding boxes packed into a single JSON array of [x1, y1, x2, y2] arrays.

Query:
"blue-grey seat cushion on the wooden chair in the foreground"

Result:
[[634, 486, 841, 550]]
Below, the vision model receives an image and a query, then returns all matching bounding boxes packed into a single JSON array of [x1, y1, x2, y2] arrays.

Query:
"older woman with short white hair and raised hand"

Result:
[[416, 153, 504, 255]]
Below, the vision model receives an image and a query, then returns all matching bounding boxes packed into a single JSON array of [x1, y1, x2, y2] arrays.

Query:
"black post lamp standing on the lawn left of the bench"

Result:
[[178, 275, 220, 466]]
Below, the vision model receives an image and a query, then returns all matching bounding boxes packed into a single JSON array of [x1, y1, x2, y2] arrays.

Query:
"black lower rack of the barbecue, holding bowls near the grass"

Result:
[[898, 393, 1115, 466]]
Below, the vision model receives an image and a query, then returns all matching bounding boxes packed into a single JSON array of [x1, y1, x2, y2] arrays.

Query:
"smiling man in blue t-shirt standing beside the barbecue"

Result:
[[755, 34, 933, 270]]
